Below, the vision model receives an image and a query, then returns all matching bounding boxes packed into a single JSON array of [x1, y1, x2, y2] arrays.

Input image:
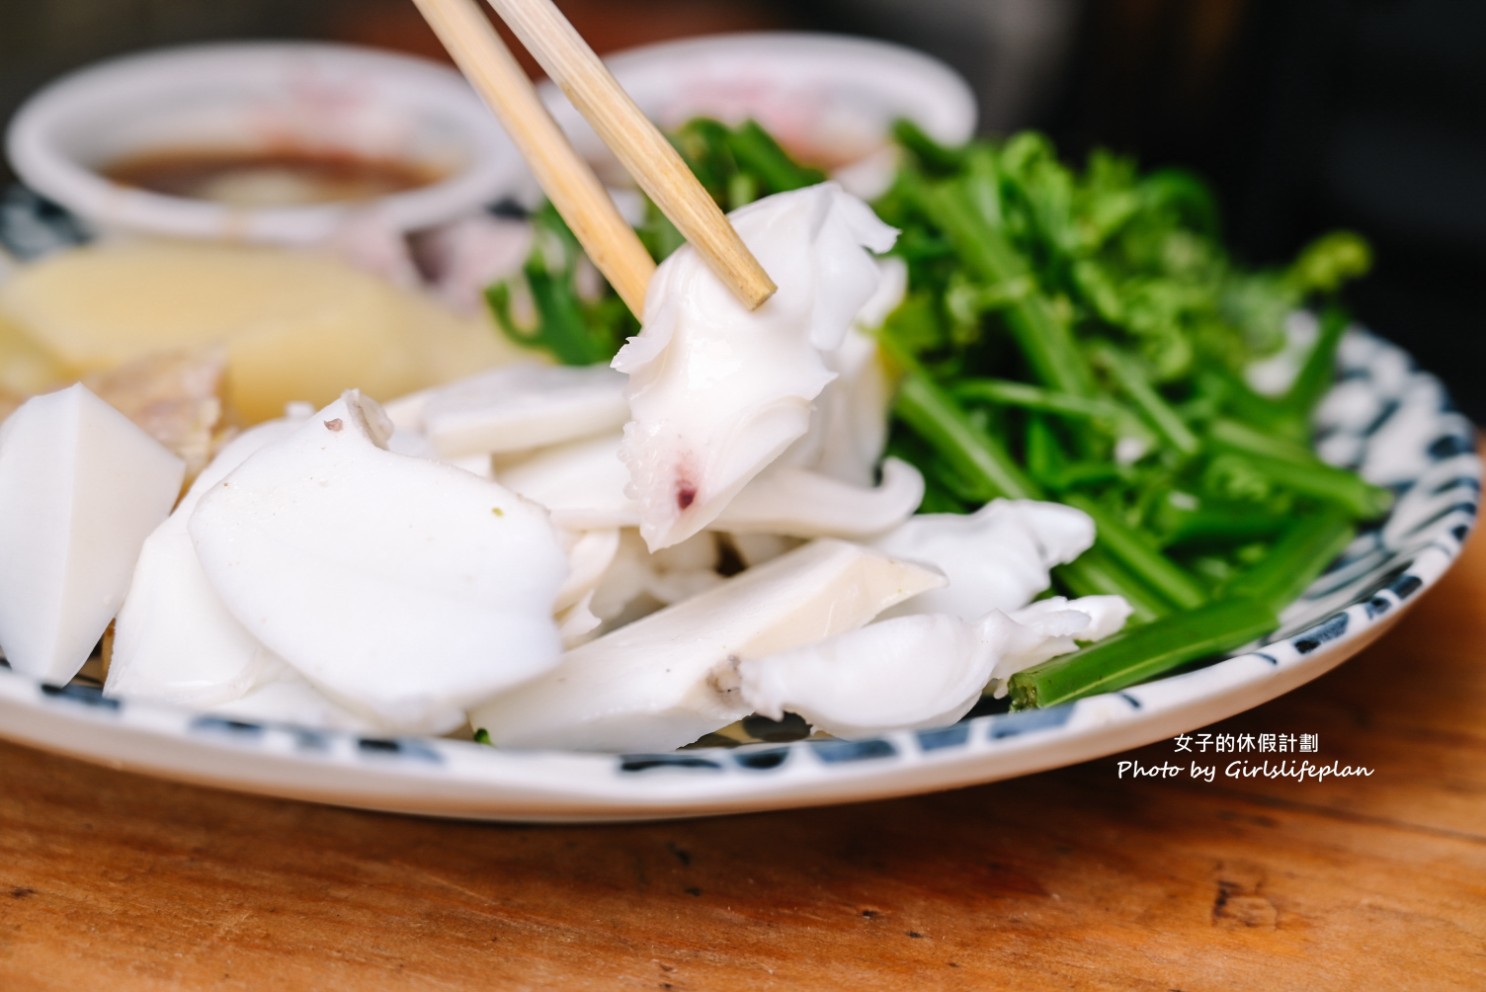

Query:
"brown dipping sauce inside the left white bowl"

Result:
[[100, 149, 443, 206]]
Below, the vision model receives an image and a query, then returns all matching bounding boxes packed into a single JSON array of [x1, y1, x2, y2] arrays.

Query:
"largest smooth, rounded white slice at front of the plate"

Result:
[[190, 392, 568, 732]]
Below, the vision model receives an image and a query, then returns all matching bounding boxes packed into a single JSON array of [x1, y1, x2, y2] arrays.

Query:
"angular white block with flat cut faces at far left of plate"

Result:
[[0, 386, 186, 683]]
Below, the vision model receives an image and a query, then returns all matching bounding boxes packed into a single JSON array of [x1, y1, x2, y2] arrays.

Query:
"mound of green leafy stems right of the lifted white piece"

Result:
[[877, 123, 1389, 707]]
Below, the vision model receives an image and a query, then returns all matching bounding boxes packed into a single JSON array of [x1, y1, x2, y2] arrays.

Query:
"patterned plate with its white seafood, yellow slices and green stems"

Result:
[[0, 32, 1480, 821]]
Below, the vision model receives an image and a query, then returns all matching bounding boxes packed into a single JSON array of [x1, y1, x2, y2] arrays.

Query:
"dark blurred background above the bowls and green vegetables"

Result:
[[0, 0, 1486, 420]]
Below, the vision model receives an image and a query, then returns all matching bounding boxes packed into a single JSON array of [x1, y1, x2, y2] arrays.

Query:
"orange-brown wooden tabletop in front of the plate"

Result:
[[0, 539, 1486, 992]]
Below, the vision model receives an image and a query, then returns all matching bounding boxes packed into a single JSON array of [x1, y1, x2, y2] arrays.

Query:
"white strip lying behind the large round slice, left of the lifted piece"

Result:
[[421, 362, 630, 459]]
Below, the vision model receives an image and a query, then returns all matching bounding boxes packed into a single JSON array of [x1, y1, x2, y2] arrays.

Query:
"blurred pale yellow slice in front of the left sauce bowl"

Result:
[[0, 242, 514, 423]]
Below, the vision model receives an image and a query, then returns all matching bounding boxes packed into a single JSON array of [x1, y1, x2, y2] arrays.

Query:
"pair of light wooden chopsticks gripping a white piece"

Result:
[[413, 0, 774, 316]]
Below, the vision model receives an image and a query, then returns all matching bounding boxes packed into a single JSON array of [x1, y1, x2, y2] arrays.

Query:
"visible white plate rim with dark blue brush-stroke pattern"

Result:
[[0, 305, 1480, 821]]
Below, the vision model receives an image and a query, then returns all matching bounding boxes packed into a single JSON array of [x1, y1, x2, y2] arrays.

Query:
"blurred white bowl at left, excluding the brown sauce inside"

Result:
[[7, 42, 525, 244]]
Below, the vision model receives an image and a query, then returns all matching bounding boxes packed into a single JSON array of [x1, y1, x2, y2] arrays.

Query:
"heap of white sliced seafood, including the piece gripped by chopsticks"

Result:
[[0, 186, 1128, 750]]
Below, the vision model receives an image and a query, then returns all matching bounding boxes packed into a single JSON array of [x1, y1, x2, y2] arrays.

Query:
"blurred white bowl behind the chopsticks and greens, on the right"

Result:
[[542, 31, 976, 196]]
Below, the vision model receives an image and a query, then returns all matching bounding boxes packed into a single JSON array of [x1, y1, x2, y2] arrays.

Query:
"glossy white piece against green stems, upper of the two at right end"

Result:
[[872, 499, 1094, 619]]
